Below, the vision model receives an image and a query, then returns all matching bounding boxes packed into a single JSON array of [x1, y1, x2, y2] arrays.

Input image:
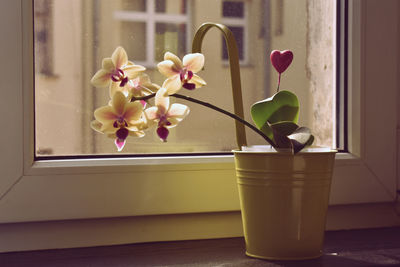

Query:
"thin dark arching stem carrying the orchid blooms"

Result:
[[131, 93, 276, 147]]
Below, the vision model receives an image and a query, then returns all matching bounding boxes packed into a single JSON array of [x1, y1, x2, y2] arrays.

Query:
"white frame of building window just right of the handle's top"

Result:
[[221, 0, 250, 65]]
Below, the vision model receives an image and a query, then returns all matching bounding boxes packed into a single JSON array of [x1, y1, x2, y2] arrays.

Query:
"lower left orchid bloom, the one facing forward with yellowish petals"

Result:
[[91, 91, 146, 151]]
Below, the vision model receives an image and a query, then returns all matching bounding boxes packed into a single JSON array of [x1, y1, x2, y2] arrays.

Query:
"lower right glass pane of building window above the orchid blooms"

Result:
[[155, 23, 187, 61]]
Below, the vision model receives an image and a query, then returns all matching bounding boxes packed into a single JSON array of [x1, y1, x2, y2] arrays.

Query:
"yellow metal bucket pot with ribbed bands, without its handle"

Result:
[[233, 148, 336, 260]]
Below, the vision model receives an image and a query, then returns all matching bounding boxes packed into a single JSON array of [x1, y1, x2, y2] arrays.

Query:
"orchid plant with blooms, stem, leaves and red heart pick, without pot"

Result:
[[91, 47, 314, 153]]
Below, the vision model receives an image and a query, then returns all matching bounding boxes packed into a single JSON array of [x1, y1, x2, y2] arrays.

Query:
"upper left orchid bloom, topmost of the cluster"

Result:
[[91, 46, 146, 88]]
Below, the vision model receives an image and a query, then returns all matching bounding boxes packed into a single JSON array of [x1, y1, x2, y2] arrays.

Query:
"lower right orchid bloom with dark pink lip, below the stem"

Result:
[[144, 87, 190, 142]]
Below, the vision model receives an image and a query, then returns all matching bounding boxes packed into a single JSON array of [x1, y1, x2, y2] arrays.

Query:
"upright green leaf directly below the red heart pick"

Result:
[[251, 91, 299, 139]]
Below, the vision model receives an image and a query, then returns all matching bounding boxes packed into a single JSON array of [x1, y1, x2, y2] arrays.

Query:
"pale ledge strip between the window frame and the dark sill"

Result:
[[0, 203, 400, 252]]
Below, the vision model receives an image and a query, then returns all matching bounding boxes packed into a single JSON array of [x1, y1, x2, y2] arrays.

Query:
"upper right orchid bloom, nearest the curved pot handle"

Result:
[[157, 52, 206, 95]]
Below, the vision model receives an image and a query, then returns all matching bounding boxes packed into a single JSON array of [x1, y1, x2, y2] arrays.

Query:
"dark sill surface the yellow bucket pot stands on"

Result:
[[0, 227, 400, 267]]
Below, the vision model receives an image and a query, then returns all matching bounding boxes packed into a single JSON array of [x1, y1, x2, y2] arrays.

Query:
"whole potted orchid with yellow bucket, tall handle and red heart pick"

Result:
[[91, 23, 336, 259]]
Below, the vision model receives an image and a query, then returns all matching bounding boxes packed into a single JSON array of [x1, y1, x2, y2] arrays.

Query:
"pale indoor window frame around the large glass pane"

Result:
[[0, 0, 399, 251]]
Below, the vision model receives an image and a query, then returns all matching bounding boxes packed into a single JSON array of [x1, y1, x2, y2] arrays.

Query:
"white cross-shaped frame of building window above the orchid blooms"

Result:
[[114, 0, 191, 67]]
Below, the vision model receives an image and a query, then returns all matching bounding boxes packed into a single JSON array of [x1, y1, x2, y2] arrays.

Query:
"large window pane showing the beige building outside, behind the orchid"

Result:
[[34, 0, 336, 157]]
